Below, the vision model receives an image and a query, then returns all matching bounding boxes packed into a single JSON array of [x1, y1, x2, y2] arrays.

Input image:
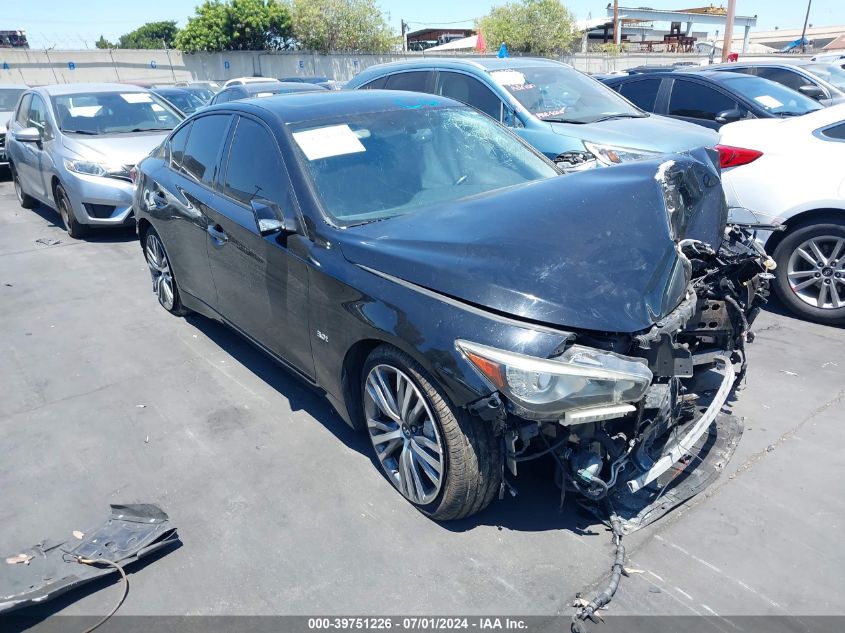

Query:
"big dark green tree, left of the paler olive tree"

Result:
[[175, 0, 292, 53]]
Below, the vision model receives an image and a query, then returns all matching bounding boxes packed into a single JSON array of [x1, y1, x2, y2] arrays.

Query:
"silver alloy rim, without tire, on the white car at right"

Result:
[[786, 235, 845, 310]]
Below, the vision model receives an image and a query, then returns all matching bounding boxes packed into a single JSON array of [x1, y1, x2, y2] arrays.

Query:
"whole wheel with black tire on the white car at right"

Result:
[[774, 220, 845, 325]]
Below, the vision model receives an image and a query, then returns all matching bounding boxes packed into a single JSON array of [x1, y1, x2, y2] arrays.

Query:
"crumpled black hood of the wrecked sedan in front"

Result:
[[339, 152, 727, 332]]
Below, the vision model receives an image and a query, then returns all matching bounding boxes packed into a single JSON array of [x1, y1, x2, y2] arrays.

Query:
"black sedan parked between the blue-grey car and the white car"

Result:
[[601, 70, 822, 130]]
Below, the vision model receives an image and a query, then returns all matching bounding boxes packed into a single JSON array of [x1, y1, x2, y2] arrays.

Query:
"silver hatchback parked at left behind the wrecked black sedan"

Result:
[[6, 84, 183, 238]]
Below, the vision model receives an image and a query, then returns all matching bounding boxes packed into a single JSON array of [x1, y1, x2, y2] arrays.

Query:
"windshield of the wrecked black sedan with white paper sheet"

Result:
[[291, 107, 560, 225]]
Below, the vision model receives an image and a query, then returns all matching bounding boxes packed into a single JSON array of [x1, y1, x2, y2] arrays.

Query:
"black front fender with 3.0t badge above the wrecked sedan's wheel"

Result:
[[309, 246, 572, 419]]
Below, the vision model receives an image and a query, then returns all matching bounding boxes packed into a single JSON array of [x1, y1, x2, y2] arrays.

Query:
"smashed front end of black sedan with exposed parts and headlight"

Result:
[[457, 151, 772, 533]]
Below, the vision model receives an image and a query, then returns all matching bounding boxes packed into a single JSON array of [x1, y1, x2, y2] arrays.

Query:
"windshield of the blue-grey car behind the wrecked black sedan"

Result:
[[490, 66, 648, 123]]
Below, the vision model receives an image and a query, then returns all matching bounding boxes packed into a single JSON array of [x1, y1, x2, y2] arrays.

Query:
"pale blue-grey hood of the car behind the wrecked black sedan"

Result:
[[550, 114, 719, 154]]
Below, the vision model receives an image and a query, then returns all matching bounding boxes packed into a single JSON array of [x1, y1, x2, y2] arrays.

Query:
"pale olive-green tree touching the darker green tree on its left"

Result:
[[292, 0, 398, 53]]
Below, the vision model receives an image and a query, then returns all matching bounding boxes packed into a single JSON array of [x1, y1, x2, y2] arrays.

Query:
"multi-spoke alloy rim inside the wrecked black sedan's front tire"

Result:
[[364, 365, 445, 505]]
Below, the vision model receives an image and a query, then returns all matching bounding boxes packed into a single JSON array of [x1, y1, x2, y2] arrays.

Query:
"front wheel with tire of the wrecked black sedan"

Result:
[[361, 345, 503, 521]]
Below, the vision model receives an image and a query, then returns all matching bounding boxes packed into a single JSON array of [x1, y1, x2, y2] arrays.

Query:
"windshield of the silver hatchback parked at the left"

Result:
[[53, 92, 183, 135]]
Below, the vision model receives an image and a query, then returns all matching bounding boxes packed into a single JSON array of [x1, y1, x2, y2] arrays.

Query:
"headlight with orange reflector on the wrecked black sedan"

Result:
[[455, 340, 652, 420]]
